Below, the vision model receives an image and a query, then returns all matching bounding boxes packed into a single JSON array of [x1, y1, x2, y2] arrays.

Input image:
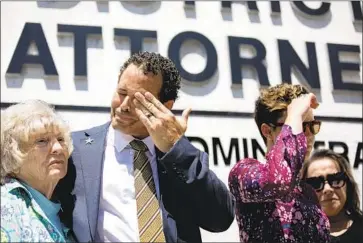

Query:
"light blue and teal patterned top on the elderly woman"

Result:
[[0, 178, 73, 242]]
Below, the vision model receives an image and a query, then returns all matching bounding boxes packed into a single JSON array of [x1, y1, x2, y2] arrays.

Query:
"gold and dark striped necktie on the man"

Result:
[[130, 140, 165, 242]]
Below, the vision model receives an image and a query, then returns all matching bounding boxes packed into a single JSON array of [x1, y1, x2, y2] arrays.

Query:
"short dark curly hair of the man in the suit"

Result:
[[118, 51, 181, 102]]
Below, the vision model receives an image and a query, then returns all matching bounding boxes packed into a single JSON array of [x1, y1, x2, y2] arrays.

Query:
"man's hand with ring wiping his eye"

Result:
[[133, 92, 191, 153]]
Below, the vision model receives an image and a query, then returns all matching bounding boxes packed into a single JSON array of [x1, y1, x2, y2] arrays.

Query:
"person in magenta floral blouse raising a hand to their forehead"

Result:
[[229, 84, 330, 243]]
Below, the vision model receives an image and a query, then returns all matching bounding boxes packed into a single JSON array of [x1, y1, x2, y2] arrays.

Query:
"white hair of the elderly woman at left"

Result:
[[0, 100, 73, 184]]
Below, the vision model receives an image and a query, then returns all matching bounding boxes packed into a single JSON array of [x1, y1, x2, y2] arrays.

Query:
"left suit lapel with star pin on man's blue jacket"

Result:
[[79, 123, 110, 239]]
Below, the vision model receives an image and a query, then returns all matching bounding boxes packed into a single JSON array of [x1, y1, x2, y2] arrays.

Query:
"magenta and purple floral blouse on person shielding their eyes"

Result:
[[228, 125, 330, 243]]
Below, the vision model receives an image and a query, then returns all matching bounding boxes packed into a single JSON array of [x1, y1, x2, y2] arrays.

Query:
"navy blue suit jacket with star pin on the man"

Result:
[[55, 123, 234, 242]]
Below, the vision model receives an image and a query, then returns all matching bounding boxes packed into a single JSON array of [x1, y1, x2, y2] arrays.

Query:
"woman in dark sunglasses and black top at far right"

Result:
[[302, 149, 363, 243]]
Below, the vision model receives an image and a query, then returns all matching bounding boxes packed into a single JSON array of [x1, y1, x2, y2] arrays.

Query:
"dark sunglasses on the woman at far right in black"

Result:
[[304, 172, 348, 192]]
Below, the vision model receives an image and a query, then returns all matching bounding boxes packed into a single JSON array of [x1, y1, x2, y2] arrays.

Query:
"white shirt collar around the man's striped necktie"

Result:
[[107, 125, 155, 155]]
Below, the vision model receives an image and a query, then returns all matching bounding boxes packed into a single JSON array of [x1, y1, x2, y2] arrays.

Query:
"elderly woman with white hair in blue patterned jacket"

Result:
[[1, 100, 75, 242]]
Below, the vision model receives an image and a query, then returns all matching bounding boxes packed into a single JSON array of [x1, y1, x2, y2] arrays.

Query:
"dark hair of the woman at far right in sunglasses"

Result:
[[301, 149, 363, 220]]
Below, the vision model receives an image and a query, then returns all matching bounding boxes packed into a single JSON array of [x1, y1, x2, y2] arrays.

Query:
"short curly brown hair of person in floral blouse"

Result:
[[254, 83, 309, 144]]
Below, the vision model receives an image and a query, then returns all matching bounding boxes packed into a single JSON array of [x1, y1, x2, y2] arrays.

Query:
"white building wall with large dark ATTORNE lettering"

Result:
[[1, 1, 363, 242]]
